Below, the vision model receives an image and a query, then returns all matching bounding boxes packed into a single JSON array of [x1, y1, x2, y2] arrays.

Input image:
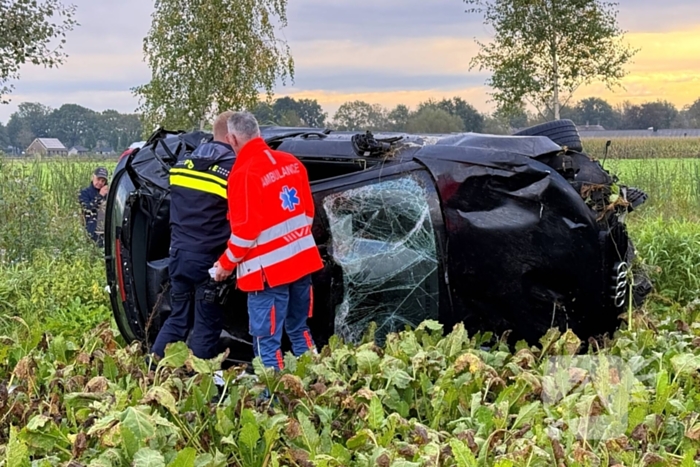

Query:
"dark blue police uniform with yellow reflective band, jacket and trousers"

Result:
[[152, 142, 235, 359]]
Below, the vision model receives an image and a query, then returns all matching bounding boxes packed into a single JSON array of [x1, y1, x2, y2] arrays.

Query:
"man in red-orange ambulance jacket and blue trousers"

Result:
[[214, 112, 323, 369]]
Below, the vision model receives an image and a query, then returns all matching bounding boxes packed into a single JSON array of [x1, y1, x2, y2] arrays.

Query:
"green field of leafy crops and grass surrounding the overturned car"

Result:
[[0, 144, 700, 467]]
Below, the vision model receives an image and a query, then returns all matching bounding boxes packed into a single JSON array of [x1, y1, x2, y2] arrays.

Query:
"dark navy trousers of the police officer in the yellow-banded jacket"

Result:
[[151, 248, 223, 359]]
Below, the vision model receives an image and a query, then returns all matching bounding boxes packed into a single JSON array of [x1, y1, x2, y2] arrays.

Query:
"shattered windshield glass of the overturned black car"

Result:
[[323, 176, 438, 343]]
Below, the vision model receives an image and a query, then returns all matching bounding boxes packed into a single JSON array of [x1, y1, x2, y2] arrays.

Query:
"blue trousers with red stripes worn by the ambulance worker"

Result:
[[248, 275, 315, 370]]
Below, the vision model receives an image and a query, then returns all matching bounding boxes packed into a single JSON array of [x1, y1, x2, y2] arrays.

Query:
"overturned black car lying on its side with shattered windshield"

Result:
[[105, 120, 651, 361]]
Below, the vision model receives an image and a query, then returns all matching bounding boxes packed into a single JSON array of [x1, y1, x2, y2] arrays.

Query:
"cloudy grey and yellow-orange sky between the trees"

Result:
[[0, 0, 700, 122]]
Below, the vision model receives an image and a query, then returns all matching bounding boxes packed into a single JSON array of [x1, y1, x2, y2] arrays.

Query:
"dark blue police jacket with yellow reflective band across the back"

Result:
[[170, 141, 235, 254]]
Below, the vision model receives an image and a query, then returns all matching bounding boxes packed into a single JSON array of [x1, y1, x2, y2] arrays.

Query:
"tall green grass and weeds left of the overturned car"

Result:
[[0, 160, 113, 340]]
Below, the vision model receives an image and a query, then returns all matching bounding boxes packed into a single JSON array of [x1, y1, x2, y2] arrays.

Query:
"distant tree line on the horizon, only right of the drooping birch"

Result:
[[253, 97, 700, 134]]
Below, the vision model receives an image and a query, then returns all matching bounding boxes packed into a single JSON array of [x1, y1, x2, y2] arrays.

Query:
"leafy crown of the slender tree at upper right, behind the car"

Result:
[[464, 0, 637, 120]]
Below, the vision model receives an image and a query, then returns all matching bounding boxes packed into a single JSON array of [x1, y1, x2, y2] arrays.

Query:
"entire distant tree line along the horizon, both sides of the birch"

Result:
[[0, 96, 700, 152]]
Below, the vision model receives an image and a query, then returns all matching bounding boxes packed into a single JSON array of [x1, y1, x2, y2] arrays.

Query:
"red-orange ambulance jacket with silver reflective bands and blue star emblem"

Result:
[[219, 138, 323, 292]]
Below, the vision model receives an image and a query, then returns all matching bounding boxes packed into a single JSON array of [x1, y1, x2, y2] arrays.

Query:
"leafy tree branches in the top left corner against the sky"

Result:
[[0, 0, 77, 104]]
